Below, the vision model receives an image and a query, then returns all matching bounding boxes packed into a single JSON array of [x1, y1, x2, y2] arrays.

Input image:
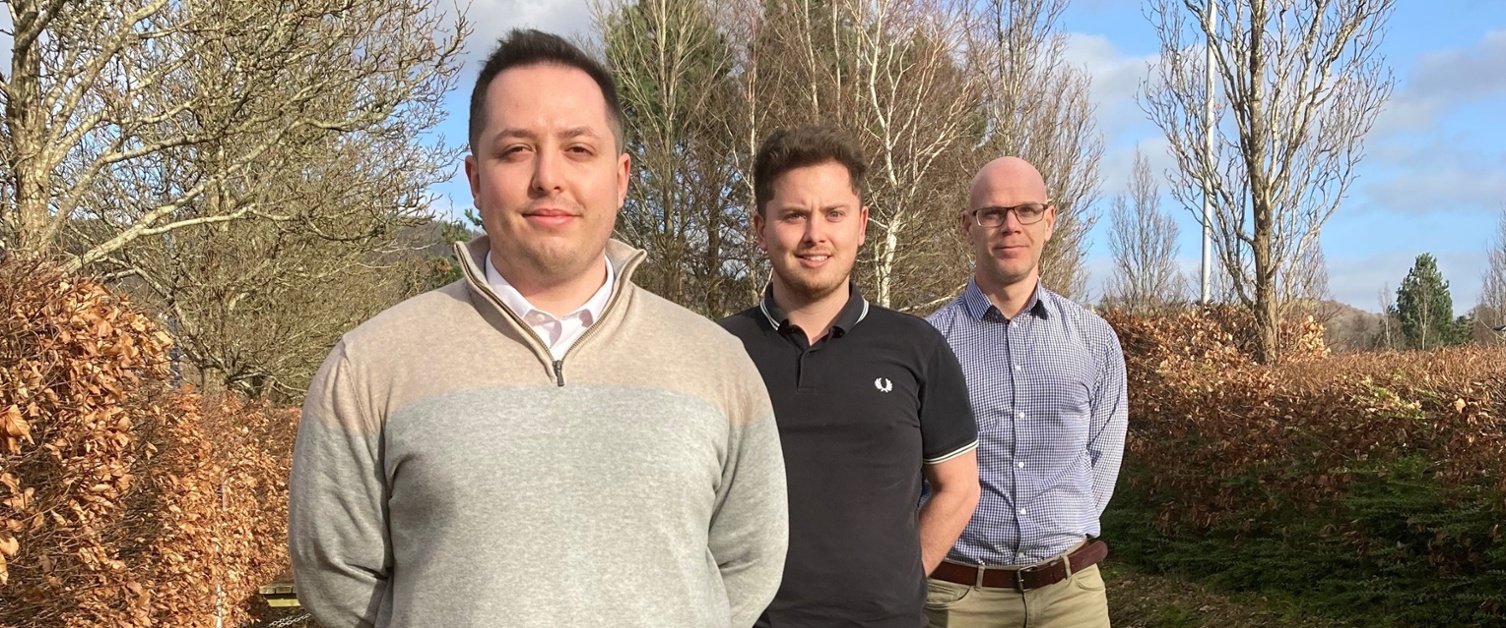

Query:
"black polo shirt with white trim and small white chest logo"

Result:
[[721, 285, 977, 628]]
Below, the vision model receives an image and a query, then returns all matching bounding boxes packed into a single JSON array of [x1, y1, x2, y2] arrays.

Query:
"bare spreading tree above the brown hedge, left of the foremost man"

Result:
[[0, 0, 467, 399]]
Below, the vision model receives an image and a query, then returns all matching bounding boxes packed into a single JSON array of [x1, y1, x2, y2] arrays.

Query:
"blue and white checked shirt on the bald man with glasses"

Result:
[[928, 280, 1130, 565]]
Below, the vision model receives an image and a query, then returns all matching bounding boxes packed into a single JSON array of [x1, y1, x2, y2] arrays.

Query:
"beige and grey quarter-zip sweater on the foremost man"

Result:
[[289, 236, 788, 628]]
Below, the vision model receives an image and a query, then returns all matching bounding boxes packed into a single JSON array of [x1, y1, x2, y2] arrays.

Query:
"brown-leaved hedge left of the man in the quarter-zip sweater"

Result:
[[0, 262, 297, 628]]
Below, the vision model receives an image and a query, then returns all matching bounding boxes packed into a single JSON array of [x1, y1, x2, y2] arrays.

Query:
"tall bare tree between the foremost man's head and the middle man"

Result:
[[593, 0, 764, 318]]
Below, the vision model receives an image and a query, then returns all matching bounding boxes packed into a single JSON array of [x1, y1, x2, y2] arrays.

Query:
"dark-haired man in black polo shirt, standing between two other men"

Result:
[[721, 128, 979, 628]]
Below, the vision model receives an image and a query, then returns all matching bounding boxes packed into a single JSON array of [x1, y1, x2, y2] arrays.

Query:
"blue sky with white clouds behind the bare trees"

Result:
[[435, 0, 1506, 313]]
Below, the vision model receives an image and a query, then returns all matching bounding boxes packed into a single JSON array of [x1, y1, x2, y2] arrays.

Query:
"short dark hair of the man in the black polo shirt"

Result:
[[753, 127, 867, 215]]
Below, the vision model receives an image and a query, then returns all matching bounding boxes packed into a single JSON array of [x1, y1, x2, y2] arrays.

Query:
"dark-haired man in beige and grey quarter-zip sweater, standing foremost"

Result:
[[289, 30, 788, 628]]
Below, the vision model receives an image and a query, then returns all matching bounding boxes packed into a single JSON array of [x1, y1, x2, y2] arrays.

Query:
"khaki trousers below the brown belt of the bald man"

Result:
[[925, 565, 1108, 628]]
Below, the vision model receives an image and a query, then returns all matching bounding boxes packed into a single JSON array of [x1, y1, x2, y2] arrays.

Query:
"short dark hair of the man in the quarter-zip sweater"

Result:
[[470, 29, 625, 154]]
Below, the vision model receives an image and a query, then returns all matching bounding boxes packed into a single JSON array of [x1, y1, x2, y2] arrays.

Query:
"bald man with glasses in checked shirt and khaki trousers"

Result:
[[925, 157, 1130, 628]]
